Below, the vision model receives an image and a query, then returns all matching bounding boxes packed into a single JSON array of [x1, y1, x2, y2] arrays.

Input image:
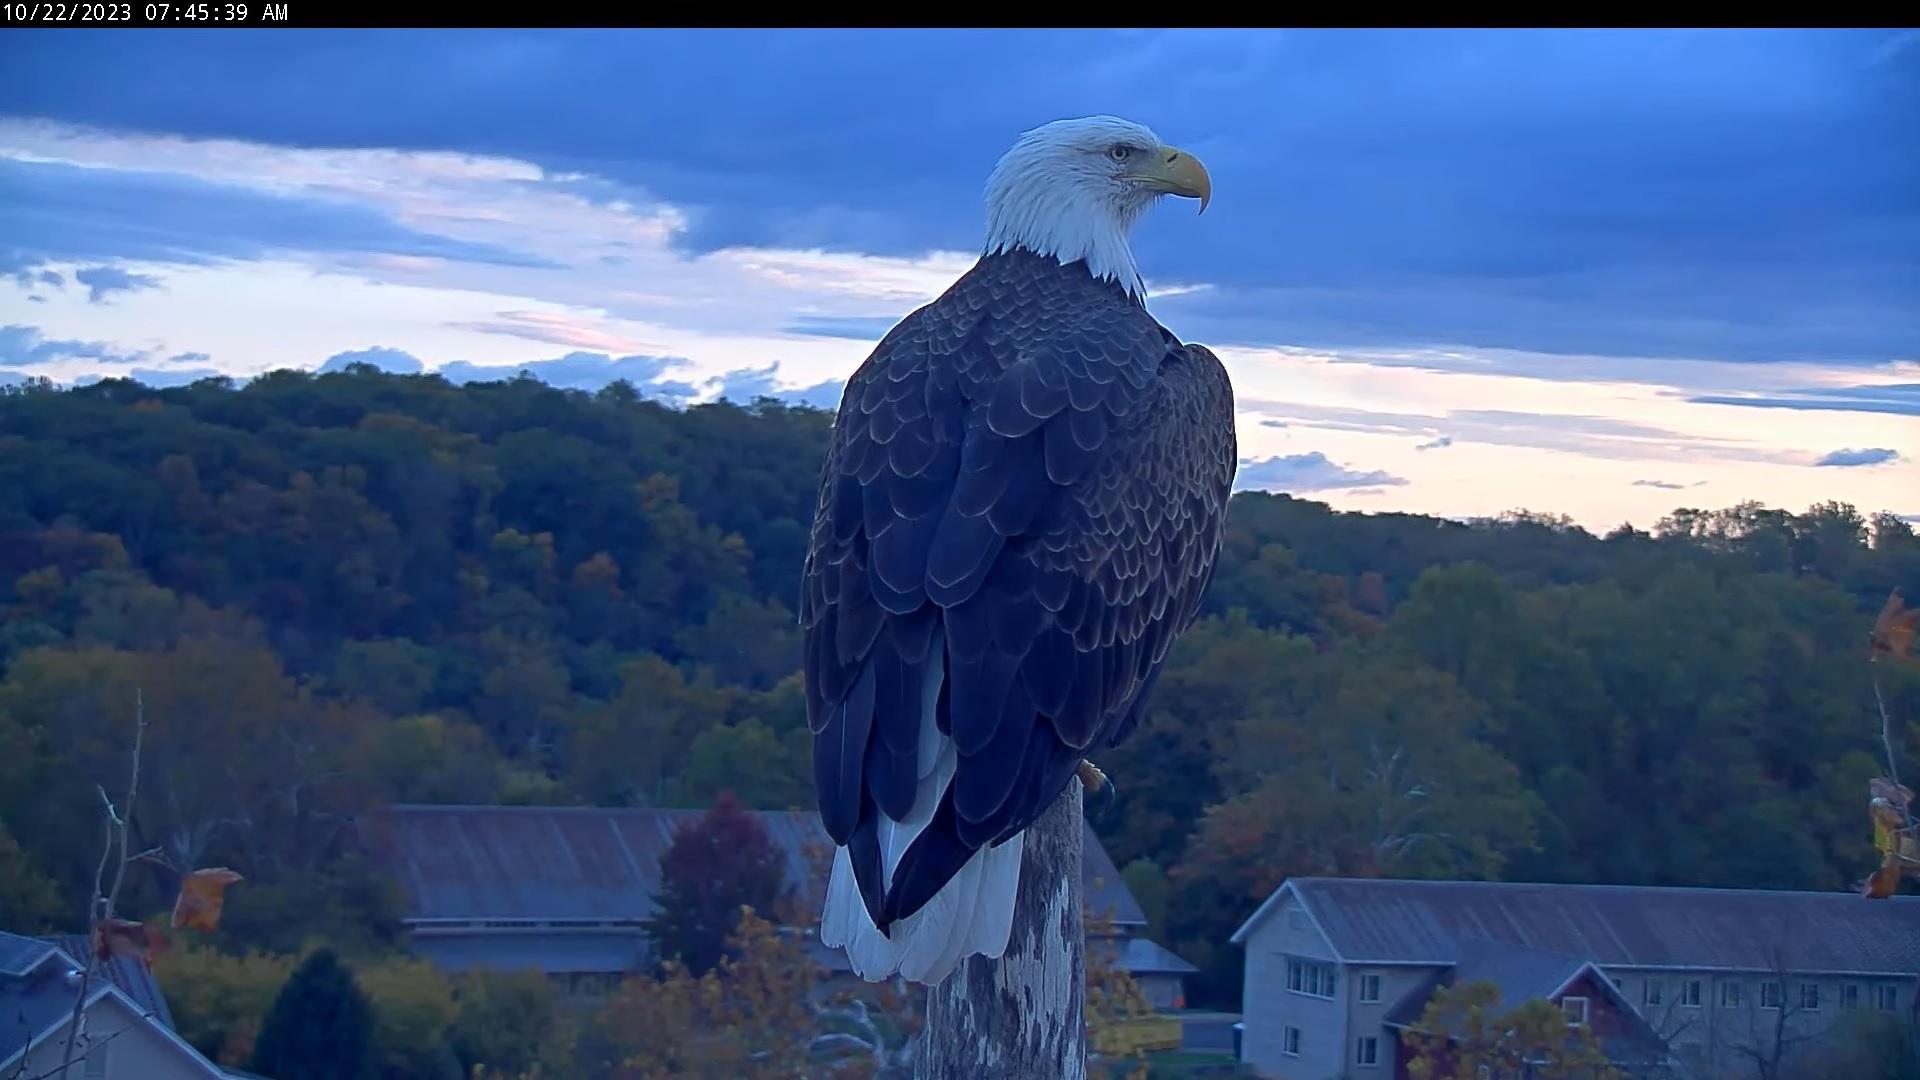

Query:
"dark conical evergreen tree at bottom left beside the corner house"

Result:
[[248, 947, 378, 1080]]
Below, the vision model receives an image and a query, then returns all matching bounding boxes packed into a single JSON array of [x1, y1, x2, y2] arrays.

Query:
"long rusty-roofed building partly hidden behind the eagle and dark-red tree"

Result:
[[365, 805, 1196, 1009]]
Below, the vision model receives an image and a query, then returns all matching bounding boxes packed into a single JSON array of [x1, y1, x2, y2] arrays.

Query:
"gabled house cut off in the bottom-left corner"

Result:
[[0, 932, 232, 1080]]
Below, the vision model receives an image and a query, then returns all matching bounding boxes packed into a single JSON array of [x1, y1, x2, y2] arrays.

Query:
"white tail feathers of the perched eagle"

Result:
[[820, 636, 1025, 986]]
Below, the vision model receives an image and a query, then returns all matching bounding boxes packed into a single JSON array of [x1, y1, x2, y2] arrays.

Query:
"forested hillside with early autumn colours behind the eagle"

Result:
[[0, 369, 1920, 1003]]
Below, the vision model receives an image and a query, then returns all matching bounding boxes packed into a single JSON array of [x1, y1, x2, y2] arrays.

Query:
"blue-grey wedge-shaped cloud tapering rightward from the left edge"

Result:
[[0, 156, 553, 270]]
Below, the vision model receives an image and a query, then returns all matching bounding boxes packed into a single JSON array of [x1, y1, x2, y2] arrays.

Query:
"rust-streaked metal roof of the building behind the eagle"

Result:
[[367, 803, 1146, 926]]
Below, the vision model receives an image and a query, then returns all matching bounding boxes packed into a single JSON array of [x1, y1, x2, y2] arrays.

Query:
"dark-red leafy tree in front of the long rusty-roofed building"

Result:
[[647, 792, 789, 976]]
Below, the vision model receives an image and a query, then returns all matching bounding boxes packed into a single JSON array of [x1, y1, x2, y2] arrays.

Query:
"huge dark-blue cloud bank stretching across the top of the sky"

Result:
[[4, 29, 1920, 359]]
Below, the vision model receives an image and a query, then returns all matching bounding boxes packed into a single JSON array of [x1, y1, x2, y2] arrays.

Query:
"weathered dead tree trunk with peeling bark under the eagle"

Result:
[[914, 776, 1087, 1080]]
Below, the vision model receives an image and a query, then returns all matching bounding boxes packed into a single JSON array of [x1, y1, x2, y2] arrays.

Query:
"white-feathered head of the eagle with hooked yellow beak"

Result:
[[987, 115, 1213, 296]]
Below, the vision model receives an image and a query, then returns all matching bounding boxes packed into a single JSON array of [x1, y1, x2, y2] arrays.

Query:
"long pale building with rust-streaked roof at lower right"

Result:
[[1233, 878, 1920, 1080]]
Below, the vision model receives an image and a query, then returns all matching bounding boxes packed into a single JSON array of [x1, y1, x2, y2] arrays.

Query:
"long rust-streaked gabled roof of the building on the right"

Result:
[[1233, 878, 1920, 976]]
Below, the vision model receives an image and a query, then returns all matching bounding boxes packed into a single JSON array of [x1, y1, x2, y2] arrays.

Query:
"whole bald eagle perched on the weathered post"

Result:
[[801, 117, 1236, 986]]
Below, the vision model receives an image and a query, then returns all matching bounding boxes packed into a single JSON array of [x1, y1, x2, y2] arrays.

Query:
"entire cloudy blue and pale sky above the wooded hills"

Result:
[[0, 31, 1920, 530]]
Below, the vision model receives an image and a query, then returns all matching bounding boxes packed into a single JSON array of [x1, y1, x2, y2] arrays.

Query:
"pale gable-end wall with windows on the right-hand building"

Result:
[[1240, 896, 1359, 1080]]
